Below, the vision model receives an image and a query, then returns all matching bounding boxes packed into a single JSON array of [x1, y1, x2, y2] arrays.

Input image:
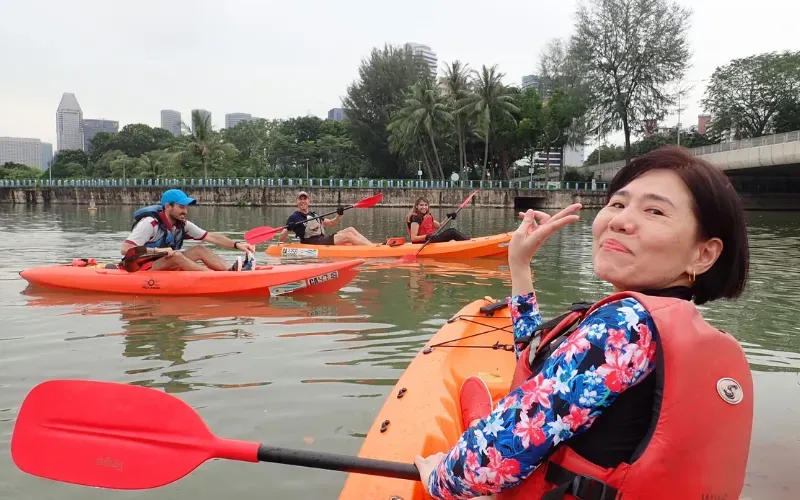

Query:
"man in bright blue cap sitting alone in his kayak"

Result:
[[120, 189, 256, 271]]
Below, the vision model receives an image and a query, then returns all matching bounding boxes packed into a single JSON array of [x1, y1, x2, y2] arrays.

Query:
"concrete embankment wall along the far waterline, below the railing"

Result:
[[0, 186, 604, 208]]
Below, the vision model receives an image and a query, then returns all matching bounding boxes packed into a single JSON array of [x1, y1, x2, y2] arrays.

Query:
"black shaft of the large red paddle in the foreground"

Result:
[[257, 444, 419, 481]]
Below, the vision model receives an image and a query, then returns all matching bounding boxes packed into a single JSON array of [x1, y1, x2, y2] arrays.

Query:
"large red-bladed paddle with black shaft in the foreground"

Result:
[[11, 380, 419, 490]]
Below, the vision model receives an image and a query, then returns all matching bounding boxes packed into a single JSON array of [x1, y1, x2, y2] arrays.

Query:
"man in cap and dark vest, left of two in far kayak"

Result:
[[279, 191, 372, 245]]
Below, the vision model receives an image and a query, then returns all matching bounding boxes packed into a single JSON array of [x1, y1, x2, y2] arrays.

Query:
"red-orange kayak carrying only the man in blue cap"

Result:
[[19, 259, 364, 295]]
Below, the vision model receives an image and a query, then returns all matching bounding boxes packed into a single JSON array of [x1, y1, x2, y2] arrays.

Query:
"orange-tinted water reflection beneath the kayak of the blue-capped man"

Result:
[[21, 285, 363, 393]]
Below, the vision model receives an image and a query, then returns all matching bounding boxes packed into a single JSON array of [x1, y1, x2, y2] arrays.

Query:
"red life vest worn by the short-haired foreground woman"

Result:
[[498, 292, 753, 500]]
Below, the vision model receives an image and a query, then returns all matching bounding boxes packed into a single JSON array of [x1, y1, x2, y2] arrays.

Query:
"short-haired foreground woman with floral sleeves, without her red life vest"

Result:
[[415, 147, 749, 499]]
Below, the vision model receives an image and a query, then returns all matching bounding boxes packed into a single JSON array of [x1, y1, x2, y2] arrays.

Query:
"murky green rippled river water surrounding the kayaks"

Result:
[[0, 205, 800, 500]]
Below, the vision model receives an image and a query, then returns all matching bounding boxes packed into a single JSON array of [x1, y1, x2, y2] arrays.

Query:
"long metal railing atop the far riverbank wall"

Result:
[[0, 177, 608, 191]]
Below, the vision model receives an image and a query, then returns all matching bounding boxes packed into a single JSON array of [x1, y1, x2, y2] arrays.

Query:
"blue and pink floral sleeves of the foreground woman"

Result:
[[428, 292, 656, 500]]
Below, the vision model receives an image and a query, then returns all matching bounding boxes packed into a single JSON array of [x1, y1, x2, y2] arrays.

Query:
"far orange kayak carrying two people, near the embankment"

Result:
[[266, 232, 513, 259]]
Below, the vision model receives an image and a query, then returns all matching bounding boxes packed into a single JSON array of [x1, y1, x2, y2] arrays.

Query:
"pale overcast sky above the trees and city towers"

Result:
[[0, 0, 800, 155]]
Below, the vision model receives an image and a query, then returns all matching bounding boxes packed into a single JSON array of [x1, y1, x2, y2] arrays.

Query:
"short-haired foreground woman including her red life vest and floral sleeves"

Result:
[[414, 146, 754, 500]]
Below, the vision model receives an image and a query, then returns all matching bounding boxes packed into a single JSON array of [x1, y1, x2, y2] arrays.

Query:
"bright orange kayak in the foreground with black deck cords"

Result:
[[339, 297, 515, 500]]
